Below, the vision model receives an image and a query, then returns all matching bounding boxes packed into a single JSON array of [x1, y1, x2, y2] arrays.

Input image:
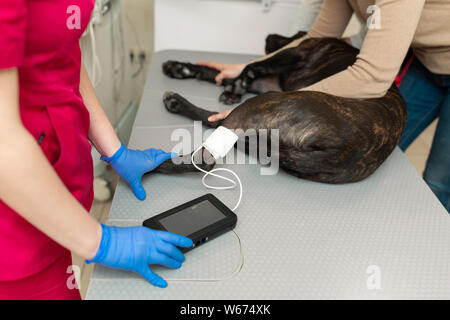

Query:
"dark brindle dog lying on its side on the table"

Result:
[[155, 33, 406, 183]]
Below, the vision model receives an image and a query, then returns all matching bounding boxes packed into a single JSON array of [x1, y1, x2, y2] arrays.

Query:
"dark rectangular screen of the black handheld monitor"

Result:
[[159, 200, 225, 236]]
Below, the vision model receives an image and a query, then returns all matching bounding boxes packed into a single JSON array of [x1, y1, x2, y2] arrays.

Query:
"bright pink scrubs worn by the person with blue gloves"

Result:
[[0, 0, 94, 299]]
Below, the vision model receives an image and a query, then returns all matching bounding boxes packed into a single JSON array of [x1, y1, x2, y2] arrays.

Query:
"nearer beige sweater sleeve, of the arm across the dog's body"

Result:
[[302, 0, 425, 98]]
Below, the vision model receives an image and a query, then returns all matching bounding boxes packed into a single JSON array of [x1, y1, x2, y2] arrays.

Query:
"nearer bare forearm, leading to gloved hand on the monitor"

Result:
[[0, 70, 101, 259]]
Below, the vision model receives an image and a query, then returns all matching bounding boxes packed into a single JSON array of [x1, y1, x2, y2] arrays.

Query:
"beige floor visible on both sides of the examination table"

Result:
[[73, 121, 437, 298]]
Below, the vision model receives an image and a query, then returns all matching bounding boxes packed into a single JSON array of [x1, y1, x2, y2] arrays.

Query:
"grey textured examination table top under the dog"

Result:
[[87, 50, 450, 299]]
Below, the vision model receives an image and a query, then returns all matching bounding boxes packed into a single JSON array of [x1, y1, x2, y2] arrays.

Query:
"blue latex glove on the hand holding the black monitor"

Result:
[[86, 224, 193, 288]]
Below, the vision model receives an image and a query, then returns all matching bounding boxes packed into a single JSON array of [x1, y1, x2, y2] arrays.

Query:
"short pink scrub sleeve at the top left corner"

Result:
[[0, 0, 27, 69]]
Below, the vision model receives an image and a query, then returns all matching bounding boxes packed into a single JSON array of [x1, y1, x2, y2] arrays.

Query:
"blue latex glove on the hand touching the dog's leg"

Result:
[[100, 144, 177, 200]]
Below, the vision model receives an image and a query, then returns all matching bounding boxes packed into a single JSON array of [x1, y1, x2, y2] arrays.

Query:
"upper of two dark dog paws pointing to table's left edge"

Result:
[[162, 60, 219, 83]]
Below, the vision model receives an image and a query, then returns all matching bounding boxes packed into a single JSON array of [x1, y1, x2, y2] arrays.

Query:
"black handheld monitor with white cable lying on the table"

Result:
[[143, 193, 237, 252]]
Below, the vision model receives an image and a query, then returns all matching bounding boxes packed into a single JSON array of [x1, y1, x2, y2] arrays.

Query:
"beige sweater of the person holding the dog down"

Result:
[[289, 0, 450, 98]]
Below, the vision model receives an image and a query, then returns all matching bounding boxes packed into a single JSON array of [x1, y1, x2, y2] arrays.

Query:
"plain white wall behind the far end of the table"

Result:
[[155, 0, 299, 54]]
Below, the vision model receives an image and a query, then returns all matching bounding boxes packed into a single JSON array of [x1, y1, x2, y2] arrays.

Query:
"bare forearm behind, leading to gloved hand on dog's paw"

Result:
[[80, 62, 121, 157]]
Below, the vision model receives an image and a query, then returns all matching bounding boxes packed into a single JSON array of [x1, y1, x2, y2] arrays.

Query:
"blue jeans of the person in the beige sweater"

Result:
[[399, 58, 450, 213]]
